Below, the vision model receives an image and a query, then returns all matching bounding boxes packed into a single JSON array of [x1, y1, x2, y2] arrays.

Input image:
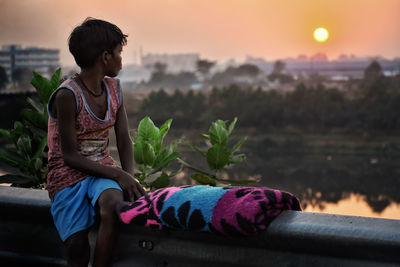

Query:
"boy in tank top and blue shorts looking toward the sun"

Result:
[[47, 18, 145, 266]]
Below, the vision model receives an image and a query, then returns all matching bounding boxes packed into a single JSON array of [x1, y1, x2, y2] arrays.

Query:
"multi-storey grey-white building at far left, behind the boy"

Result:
[[0, 45, 60, 81]]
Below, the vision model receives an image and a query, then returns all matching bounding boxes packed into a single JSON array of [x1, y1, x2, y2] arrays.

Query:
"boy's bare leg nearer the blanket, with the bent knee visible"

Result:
[[93, 188, 123, 267]]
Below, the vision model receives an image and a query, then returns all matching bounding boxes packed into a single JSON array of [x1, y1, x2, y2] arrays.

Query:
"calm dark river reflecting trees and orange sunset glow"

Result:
[[167, 135, 400, 219]]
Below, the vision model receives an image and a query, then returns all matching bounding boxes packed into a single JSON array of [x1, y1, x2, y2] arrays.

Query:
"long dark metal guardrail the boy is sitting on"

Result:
[[0, 186, 400, 267]]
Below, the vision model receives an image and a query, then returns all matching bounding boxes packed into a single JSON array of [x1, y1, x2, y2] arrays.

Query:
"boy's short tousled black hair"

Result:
[[68, 18, 128, 68]]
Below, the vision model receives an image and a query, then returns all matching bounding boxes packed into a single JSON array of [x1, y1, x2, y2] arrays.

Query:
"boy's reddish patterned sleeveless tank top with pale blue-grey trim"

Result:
[[47, 77, 121, 199]]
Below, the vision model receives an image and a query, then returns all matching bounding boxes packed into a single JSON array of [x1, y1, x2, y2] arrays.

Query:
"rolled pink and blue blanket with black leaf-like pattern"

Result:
[[119, 185, 301, 236]]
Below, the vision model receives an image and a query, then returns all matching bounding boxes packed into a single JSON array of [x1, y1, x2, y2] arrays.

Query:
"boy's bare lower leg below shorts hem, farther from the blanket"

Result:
[[64, 230, 90, 267]]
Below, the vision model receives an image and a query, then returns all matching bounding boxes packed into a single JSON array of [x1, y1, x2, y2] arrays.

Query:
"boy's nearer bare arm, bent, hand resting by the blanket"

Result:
[[55, 90, 144, 201]]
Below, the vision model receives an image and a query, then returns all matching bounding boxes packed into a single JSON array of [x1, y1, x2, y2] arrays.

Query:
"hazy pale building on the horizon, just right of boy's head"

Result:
[[141, 53, 200, 73]]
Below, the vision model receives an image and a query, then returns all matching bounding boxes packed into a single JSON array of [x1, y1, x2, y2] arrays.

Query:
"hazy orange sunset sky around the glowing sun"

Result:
[[0, 0, 400, 65]]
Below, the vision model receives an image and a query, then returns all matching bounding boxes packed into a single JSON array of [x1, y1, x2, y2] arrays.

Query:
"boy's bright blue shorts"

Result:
[[51, 176, 122, 242]]
